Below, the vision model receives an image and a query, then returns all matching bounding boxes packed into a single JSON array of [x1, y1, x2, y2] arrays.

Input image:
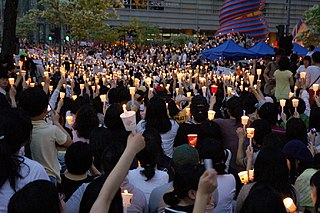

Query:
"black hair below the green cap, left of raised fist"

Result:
[[163, 165, 205, 206]]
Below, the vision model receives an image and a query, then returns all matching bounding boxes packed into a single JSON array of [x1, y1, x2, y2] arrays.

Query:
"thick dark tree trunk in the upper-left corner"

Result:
[[1, 0, 19, 55]]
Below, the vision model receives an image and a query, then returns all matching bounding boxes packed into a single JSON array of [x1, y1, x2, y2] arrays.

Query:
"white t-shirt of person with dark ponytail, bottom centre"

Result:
[[127, 167, 169, 202]]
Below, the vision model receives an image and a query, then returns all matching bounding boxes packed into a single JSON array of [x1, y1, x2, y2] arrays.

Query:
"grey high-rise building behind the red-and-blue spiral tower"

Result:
[[109, 0, 320, 37]]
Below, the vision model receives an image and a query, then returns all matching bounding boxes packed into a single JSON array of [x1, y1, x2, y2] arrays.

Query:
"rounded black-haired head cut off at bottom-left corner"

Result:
[[8, 180, 61, 213]]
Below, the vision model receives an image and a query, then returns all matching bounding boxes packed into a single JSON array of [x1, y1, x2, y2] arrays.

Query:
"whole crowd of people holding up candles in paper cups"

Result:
[[0, 38, 320, 213]]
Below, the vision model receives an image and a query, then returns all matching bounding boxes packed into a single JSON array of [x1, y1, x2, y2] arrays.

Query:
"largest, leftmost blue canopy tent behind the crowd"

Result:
[[201, 40, 257, 61]]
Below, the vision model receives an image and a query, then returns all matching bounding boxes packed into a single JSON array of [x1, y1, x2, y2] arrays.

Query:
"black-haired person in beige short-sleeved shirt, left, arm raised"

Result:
[[19, 88, 72, 185]]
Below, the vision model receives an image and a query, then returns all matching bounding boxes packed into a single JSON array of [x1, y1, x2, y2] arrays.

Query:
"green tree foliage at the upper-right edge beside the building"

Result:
[[297, 4, 320, 46]]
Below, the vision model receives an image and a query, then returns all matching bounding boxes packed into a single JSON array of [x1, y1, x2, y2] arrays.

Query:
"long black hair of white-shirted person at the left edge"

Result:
[[0, 109, 32, 191]]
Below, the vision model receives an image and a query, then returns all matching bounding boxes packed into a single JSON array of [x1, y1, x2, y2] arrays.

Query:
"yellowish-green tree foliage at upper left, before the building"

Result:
[[20, 0, 122, 41]]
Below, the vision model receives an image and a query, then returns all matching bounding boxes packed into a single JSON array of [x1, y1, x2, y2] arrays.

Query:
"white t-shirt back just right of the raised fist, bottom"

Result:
[[214, 174, 236, 213]]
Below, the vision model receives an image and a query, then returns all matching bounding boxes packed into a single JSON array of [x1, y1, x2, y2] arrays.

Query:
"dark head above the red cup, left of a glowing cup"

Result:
[[190, 95, 209, 123]]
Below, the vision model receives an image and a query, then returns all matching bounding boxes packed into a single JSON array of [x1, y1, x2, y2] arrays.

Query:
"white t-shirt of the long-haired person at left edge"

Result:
[[0, 157, 49, 213]]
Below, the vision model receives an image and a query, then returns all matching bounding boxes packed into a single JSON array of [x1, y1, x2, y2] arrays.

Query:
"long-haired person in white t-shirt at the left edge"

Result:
[[0, 109, 49, 213]]
